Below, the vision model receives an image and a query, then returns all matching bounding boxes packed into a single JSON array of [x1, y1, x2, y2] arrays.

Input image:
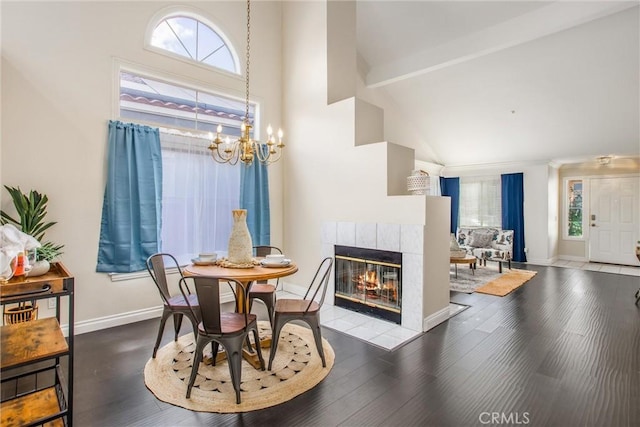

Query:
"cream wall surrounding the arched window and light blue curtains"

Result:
[[0, 1, 282, 332]]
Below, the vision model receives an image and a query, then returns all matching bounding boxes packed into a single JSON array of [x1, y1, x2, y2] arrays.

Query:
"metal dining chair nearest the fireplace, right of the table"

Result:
[[268, 257, 333, 370]]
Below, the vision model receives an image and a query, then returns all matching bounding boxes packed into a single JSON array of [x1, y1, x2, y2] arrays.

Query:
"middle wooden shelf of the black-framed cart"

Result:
[[0, 317, 69, 369]]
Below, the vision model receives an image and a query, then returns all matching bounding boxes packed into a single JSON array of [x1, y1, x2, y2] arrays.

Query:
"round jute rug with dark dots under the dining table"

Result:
[[144, 321, 335, 413]]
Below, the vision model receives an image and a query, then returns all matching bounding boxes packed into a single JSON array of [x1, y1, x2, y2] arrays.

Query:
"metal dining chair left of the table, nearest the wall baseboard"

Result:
[[147, 253, 200, 358]]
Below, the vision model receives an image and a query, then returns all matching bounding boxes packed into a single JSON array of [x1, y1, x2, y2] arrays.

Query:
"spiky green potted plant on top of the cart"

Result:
[[0, 185, 64, 276]]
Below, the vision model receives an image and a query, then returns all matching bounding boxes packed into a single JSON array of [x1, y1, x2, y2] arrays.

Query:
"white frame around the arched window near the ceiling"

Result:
[[144, 6, 245, 77]]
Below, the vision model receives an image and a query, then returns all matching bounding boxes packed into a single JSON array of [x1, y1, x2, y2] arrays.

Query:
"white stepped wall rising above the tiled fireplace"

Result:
[[283, 2, 449, 328]]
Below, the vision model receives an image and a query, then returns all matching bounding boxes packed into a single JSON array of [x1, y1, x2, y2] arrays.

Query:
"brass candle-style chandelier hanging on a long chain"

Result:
[[208, 0, 284, 165]]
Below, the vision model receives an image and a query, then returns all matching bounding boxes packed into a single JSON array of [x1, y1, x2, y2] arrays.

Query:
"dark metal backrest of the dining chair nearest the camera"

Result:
[[180, 276, 248, 335]]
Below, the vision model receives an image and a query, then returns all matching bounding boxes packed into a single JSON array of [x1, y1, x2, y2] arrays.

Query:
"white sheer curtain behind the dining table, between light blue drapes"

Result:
[[160, 131, 240, 263]]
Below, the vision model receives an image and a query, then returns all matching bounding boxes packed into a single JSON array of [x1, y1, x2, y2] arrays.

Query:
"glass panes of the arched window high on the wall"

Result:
[[148, 13, 240, 74]]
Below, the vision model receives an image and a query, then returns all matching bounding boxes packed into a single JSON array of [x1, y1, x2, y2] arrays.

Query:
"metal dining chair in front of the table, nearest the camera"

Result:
[[180, 276, 264, 403]]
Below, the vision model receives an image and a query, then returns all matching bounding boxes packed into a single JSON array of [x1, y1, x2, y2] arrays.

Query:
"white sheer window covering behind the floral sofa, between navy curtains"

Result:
[[460, 176, 502, 228]]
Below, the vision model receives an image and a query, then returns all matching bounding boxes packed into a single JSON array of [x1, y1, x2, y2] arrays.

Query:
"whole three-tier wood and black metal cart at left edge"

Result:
[[0, 263, 74, 427]]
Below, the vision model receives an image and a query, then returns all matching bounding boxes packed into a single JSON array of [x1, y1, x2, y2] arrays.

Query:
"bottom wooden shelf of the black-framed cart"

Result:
[[0, 387, 64, 427]]
